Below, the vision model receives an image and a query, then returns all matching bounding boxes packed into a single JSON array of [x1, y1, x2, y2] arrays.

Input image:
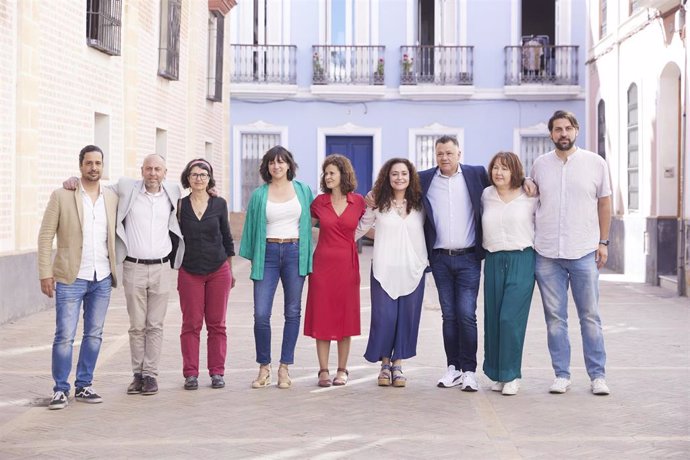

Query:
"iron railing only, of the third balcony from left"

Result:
[[400, 45, 474, 85]]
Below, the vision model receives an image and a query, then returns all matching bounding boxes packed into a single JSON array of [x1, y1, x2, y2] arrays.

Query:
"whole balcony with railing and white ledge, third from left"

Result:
[[400, 45, 474, 99]]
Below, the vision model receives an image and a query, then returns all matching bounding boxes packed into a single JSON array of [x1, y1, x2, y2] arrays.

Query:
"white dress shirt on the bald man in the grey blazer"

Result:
[[124, 182, 172, 259]]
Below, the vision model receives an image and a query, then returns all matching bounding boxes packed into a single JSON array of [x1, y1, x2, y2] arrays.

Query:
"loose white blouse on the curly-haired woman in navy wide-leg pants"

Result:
[[355, 208, 428, 299]]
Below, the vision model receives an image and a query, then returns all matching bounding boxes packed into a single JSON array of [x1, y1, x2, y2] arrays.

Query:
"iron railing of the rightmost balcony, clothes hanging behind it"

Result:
[[505, 45, 578, 85]]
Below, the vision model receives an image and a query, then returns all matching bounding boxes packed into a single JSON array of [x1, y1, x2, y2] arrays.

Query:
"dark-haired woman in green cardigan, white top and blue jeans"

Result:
[[240, 145, 314, 389]]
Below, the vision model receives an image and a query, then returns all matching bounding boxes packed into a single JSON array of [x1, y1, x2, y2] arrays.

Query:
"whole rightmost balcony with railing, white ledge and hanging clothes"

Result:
[[505, 44, 581, 99]]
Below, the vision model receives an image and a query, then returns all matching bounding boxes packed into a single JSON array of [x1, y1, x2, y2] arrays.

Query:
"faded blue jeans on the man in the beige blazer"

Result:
[[53, 276, 112, 393]]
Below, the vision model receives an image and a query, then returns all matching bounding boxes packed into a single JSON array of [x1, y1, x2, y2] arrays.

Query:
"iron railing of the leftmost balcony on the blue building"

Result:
[[230, 44, 297, 85]]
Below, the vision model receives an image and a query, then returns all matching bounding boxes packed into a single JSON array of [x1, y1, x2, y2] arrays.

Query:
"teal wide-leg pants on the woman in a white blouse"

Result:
[[484, 248, 535, 382]]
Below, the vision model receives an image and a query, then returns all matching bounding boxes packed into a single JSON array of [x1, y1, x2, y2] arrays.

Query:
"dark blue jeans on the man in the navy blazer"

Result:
[[431, 253, 482, 372]]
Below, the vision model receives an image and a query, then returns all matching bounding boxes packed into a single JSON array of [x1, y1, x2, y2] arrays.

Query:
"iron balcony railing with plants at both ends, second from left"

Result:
[[312, 45, 386, 85]]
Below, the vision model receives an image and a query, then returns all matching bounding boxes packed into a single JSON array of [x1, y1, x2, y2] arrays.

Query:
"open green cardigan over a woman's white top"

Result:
[[240, 180, 314, 281]]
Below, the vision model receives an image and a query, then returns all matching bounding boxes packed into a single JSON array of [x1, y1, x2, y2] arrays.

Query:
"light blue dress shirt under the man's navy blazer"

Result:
[[427, 165, 476, 249]]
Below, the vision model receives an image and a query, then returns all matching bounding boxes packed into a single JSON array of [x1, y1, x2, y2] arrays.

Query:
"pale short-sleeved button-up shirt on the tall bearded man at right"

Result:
[[532, 148, 611, 260]]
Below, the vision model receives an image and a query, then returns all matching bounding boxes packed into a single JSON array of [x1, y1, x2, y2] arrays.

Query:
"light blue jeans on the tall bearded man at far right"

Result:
[[535, 253, 606, 380]]
